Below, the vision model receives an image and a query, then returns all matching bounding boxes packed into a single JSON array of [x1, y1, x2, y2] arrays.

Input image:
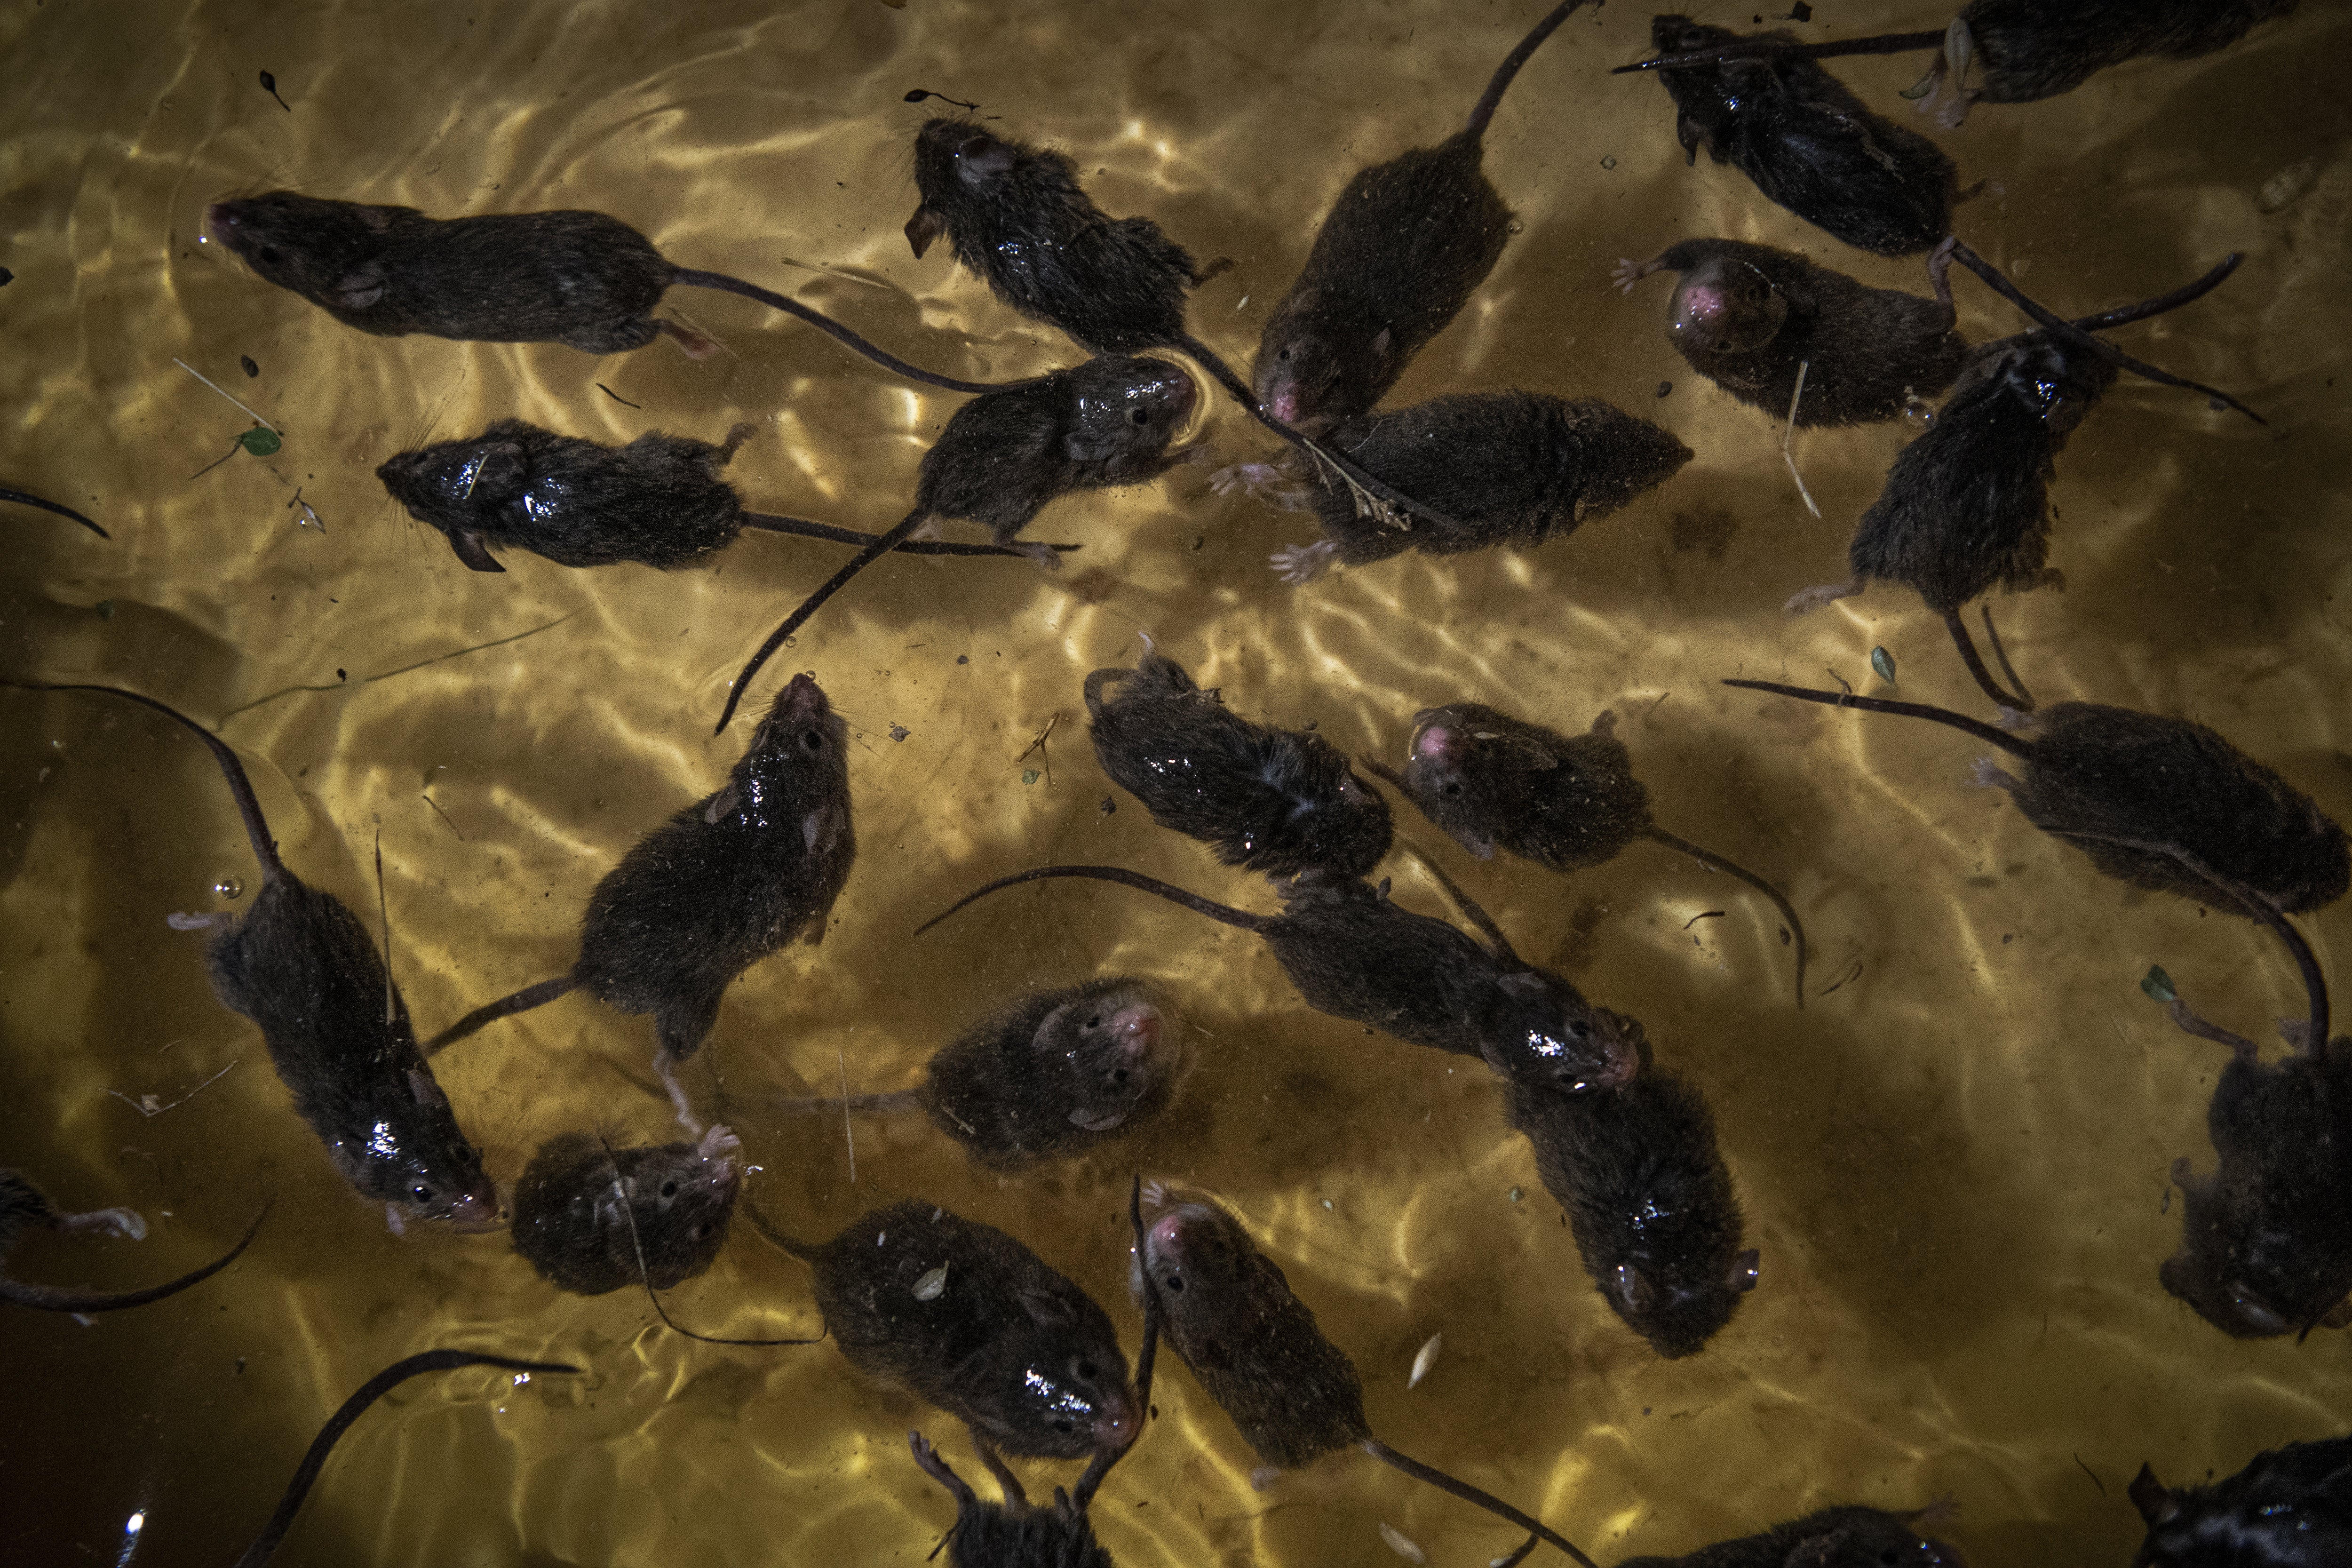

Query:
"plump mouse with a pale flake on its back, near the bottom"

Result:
[[748, 1199, 1143, 1460]]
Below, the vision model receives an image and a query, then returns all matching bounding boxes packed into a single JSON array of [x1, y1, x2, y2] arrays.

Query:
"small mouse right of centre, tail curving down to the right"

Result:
[[1383, 703, 1806, 1006]]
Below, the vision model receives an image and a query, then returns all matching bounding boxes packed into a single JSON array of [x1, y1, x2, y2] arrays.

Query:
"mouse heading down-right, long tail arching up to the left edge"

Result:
[[5, 682, 499, 1232]]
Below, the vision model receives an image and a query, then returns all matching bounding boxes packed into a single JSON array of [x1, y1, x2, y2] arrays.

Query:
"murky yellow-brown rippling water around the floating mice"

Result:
[[0, 0, 2352, 1568]]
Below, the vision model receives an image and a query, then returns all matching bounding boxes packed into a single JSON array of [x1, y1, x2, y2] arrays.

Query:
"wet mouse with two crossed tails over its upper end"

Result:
[[1788, 240, 2260, 710]]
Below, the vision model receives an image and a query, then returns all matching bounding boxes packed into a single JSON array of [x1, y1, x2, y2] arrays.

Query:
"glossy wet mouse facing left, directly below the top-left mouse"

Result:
[[376, 418, 1077, 571]]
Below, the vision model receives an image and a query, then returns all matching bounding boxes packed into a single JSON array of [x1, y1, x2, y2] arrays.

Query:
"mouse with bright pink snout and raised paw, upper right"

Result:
[[1616, 240, 1969, 428]]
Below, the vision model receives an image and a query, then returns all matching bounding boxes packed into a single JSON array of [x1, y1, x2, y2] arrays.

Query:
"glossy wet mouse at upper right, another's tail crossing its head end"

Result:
[[1649, 14, 1959, 256]]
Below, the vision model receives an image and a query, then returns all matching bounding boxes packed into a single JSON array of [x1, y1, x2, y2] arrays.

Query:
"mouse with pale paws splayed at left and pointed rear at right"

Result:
[[1272, 392, 1691, 583]]
